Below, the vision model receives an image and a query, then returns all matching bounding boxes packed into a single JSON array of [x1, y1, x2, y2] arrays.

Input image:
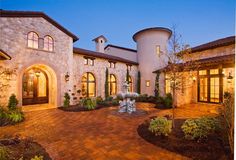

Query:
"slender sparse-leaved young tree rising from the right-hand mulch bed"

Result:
[[162, 26, 199, 127]]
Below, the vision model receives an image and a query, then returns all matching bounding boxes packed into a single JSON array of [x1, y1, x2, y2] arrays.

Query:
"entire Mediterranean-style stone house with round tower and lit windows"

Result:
[[0, 10, 235, 107]]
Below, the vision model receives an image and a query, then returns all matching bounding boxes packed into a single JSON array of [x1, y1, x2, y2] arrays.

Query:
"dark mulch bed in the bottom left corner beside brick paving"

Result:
[[0, 137, 52, 160]]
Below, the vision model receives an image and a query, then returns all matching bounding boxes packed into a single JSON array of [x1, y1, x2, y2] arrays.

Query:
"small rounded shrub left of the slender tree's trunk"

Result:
[[148, 117, 172, 136]]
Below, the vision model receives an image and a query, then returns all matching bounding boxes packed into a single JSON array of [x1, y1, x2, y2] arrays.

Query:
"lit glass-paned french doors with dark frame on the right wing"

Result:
[[198, 69, 223, 103]]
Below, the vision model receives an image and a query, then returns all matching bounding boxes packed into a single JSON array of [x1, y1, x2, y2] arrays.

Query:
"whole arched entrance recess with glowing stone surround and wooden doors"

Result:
[[20, 64, 60, 107]]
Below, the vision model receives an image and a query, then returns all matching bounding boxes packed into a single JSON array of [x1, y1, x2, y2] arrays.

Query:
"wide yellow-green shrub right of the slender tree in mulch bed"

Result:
[[181, 117, 220, 140]]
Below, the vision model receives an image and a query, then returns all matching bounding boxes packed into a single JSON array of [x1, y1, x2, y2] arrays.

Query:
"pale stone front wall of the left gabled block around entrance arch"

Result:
[[0, 17, 73, 106]]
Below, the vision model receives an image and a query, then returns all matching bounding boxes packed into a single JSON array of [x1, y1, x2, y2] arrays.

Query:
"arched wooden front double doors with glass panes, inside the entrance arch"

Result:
[[22, 68, 48, 105]]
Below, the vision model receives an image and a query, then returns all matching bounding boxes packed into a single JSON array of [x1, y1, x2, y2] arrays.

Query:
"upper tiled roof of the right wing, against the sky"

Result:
[[191, 36, 235, 53]]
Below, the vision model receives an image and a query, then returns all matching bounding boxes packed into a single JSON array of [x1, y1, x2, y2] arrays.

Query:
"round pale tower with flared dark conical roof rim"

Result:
[[133, 27, 172, 95]]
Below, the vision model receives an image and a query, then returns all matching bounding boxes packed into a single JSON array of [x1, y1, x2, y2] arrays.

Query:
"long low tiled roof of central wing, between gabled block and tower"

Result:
[[73, 47, 138, 65]]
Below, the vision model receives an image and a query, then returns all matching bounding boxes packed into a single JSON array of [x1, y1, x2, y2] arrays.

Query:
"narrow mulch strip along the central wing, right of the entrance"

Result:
[[58, 105, 115, 112]]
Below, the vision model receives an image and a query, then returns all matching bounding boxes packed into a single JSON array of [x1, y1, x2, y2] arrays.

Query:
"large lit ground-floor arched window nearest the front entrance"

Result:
[[81, 72, 96, 97]]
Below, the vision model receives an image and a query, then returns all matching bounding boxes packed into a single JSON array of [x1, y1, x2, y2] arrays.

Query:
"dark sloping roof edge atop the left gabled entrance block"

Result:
[[0, 9, 79, 42]]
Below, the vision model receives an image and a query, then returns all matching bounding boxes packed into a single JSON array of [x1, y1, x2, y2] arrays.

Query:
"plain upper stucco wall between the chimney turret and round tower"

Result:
[[105, 46, 138, 62]]
